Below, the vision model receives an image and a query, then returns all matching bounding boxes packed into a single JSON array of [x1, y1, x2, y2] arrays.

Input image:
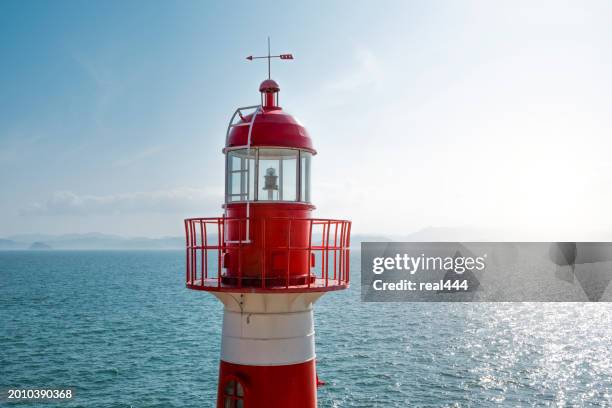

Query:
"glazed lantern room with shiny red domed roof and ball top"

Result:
[[224, 79, 316, 205]]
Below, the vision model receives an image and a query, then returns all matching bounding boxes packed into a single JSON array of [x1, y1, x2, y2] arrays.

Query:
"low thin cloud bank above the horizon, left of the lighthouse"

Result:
[[21, 187, 223, 216]]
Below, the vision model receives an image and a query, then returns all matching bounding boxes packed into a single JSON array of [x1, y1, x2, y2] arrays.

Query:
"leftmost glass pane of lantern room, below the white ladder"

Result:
[[226, 149, 255, 202]]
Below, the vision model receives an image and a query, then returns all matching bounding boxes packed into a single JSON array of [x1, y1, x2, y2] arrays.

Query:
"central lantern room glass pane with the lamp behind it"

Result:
[[257, 149, 298, 201]]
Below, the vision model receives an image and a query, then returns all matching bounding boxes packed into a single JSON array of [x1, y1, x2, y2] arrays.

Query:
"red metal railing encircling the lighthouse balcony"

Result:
[[185, 217, 351, 292]]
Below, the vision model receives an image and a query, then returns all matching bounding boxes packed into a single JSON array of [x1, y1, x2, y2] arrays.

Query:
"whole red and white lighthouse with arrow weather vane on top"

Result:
[[185, 43, 351, 408]]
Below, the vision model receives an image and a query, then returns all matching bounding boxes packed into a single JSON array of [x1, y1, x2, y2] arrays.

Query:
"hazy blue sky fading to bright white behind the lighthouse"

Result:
[[0, 0, 612, 240]]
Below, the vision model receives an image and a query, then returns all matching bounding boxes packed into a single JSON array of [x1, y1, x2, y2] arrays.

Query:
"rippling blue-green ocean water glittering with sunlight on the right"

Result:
[[0, 251, 612, 407]]
